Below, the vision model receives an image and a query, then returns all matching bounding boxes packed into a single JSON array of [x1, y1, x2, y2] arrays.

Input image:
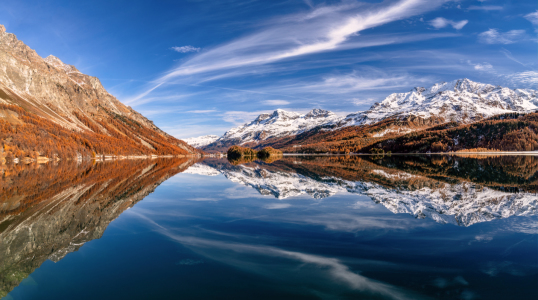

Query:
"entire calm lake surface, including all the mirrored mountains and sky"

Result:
[[0, 155, 538, 300]]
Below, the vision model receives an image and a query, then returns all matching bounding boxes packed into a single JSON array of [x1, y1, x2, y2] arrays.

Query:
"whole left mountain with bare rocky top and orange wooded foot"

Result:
[[0, 25, 200, 161]]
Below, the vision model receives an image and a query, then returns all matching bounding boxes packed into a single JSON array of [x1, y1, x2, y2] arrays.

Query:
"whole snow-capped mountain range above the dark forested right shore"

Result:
[[202, 79, 538, 151]]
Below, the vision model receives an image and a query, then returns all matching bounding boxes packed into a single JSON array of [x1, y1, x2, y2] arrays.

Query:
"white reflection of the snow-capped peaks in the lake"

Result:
[[195, 161, 538, 226]]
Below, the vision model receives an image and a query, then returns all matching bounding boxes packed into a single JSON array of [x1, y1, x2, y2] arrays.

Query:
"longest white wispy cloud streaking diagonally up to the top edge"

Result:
[[135, 0, 447, 99]]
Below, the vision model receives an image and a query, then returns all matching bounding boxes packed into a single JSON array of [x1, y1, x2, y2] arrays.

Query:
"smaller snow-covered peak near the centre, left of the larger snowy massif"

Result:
[[218, 109, 341, 144]]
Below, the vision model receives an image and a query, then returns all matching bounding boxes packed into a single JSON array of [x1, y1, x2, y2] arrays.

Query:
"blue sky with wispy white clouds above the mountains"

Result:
[[0, 0, 538, 138]]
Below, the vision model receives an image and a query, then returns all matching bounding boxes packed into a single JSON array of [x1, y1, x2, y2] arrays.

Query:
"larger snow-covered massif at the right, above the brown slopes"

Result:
[[338, 79, 538, 127]]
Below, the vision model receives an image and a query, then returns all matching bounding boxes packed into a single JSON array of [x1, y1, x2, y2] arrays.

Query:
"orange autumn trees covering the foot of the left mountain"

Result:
[[0, 104, 197, 161]]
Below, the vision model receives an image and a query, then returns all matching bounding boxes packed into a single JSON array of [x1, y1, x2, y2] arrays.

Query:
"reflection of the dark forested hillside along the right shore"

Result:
[[215, 155, 538, 192]]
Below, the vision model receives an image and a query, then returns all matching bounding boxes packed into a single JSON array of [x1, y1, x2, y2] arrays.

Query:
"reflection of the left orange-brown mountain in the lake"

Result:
[[0, 158, 194, 297]]
